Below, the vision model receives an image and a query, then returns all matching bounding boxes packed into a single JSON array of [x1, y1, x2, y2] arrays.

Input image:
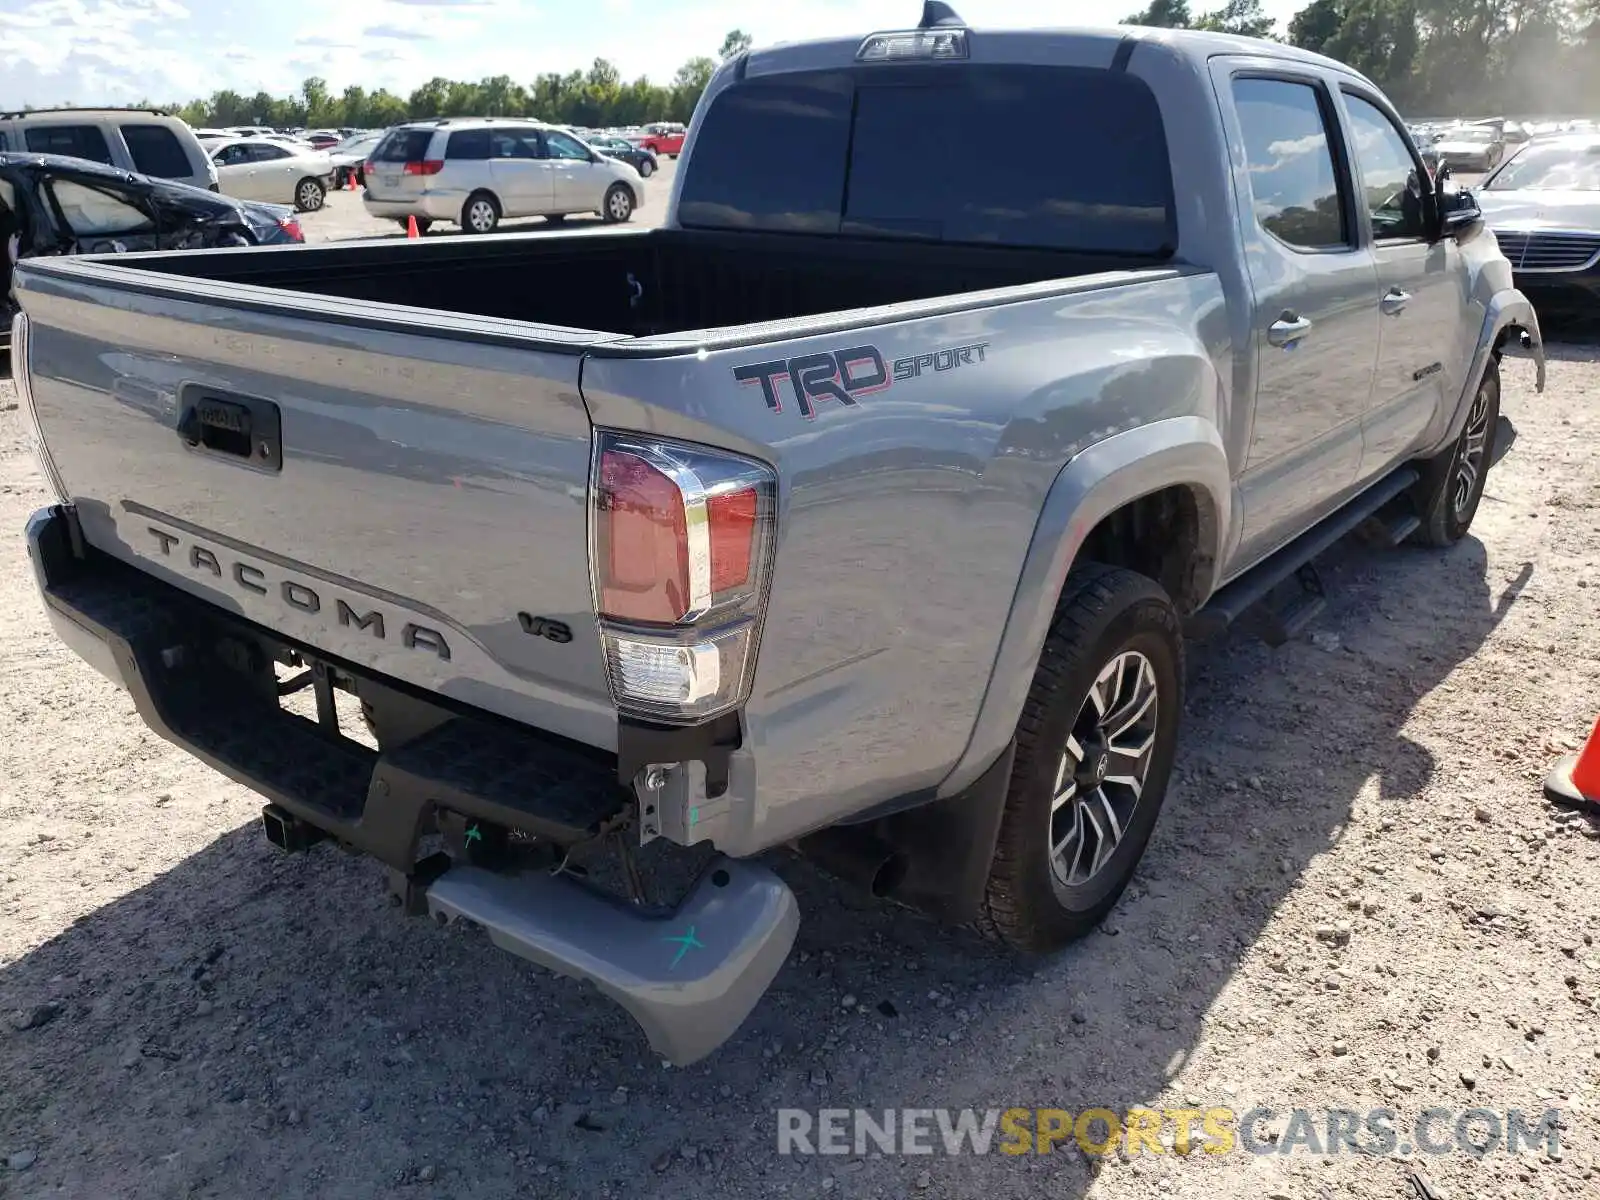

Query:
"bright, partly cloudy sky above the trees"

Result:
[[0, 0, 1301, 109]]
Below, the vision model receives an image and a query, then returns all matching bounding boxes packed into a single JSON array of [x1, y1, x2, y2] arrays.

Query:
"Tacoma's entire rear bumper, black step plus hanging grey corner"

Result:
[[27, 507, 800, 1064]]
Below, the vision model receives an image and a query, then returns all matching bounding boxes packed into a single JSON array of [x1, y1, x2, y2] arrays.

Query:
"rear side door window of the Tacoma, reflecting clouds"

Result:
[[1234, 78, 1350, 250]]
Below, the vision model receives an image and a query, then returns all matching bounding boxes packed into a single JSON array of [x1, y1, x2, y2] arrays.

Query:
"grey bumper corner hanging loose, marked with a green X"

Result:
[[426, 858, 800, 1066]]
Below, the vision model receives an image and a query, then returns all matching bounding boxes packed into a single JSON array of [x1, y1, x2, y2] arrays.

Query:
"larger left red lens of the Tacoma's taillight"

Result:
[[597, 450, 690, 624]]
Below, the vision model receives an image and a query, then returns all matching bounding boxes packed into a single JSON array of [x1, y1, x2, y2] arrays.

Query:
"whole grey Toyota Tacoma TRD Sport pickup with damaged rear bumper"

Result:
[[14, 3, 1542, 1061]]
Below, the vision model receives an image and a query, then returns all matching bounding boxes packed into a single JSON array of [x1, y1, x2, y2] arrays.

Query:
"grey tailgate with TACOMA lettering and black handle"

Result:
[[21, 261, 616, 749]]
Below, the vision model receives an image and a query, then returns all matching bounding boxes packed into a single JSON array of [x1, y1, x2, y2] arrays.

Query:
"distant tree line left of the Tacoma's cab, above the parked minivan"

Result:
[[168, 29, 750, 130]]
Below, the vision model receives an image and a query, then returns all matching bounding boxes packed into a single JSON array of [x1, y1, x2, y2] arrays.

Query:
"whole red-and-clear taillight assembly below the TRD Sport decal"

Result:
[[590, 432, 778, 722]]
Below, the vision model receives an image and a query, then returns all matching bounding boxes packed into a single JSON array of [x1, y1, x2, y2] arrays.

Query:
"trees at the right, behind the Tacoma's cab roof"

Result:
[[1125, 0, 1600, 117]]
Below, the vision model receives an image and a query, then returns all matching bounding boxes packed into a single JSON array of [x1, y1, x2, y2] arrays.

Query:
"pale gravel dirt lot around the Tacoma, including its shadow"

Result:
[[0, 299, 1600, 1200]]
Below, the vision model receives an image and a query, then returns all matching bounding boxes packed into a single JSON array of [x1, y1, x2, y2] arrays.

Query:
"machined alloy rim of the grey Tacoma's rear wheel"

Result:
[[1050, 650, 1160, 888]]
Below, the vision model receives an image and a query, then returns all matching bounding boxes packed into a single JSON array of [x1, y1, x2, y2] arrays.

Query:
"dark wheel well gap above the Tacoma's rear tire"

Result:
[[1078, 483, 1216, 613]]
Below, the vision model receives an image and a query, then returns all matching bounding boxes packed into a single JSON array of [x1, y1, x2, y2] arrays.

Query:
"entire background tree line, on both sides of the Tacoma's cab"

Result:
[[106, 0, 1600, 128]]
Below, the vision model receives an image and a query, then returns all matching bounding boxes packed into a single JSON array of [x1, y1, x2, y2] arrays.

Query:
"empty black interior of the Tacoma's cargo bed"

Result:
[[117, 229, 1162, 338]]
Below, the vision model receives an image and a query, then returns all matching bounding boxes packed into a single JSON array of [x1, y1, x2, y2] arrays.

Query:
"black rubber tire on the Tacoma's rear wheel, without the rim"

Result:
[[978, 563, 1184, 952]]
